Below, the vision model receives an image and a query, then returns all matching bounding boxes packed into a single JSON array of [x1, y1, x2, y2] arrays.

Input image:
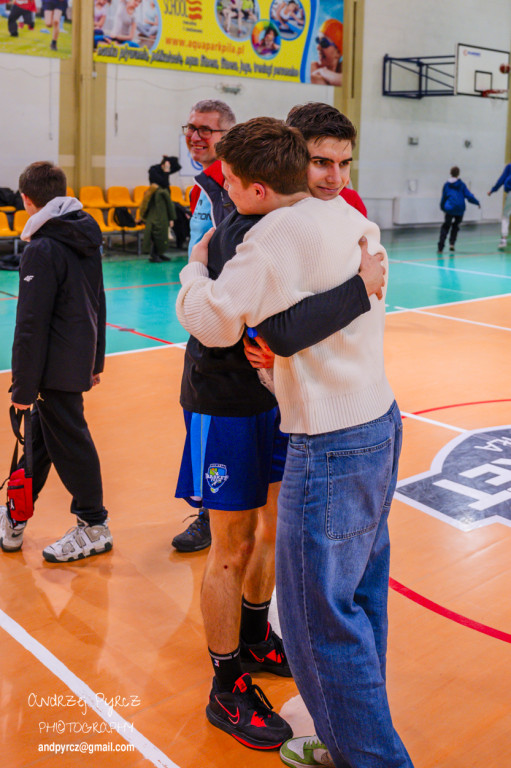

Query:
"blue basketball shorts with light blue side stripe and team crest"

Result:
[[176, 408, 287, 511]]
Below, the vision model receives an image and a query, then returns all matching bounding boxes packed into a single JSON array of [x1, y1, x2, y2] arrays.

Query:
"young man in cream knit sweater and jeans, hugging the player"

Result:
[[177, 118, 412, 768]]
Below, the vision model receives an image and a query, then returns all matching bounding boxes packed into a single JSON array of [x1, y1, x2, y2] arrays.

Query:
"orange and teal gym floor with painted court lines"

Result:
[[0, 226, 511, 768]]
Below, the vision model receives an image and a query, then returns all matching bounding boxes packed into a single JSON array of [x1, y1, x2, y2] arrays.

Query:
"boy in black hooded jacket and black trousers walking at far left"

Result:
[[0, 162, 112, 562]]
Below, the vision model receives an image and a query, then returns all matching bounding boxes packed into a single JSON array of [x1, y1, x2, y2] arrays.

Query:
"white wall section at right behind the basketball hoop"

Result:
[[359, 0, 511, 228]]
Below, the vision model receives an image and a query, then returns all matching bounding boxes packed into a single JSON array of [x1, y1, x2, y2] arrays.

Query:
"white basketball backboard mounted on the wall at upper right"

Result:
[[455, 43, 509, 99]]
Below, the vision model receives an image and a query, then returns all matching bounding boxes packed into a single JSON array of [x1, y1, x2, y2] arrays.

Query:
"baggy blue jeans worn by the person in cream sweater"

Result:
[[276, 402, 412, 768]]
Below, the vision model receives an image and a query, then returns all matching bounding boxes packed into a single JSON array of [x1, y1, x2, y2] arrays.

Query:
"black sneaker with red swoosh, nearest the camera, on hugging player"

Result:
[[206, 672, 293, 750]]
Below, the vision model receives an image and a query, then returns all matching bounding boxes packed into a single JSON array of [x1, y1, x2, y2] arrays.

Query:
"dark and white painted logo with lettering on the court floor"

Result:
[[395, 425, 511, 531]]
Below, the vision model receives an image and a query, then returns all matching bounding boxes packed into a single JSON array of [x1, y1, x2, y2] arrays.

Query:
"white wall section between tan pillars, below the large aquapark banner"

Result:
[[105, 64, 333, 187]]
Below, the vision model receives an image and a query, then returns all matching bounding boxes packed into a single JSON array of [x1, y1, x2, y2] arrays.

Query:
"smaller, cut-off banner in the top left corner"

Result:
[[0, 0, 72, 59]]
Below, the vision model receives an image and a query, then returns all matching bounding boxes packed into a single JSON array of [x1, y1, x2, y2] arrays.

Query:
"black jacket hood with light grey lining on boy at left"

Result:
[[21, 197, 103, 258]]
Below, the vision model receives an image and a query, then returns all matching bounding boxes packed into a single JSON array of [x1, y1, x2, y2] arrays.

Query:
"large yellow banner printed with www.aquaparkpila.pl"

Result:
[[94, 0, 343, 85]]
